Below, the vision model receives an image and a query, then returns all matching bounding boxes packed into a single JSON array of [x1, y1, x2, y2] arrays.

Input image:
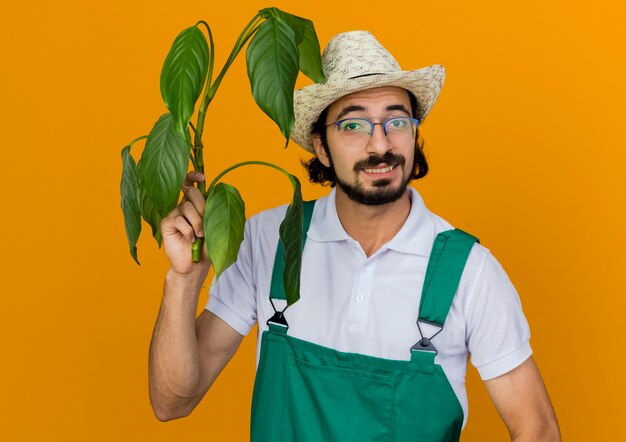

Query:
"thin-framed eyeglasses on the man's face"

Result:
[[326, 117, 419, 147]]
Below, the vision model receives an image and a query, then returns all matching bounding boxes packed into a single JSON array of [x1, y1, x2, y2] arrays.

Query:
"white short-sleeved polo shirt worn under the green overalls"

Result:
[[206, 188, 532, 425]]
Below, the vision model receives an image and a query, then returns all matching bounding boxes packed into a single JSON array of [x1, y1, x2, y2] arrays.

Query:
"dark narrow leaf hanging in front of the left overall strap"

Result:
[[279, 175, 304, 305]]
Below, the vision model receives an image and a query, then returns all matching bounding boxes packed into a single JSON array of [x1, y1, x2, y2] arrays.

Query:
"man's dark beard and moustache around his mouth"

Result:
[[331, 152, 411, 206]]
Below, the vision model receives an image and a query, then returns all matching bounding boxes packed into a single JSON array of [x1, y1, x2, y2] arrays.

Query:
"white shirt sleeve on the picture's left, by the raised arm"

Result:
[[206, 217, 257, 336]]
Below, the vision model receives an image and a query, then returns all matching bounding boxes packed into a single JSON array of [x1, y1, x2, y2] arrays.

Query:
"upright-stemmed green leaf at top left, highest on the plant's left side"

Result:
[[161, 26, 209, 136]]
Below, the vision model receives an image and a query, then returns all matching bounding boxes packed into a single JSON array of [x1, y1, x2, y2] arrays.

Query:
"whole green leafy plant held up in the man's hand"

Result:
[[120, 8, 324, 304]]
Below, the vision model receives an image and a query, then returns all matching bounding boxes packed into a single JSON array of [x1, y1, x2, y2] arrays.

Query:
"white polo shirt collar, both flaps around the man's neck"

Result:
[[307, 187, 435, 256]]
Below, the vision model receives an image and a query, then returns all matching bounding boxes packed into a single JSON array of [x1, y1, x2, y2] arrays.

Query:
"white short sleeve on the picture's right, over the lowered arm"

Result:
[[466, 253, 532, 381]]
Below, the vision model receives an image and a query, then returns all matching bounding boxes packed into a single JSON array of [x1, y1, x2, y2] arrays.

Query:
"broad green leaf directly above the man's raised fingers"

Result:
[[138, 113, 190, 218]]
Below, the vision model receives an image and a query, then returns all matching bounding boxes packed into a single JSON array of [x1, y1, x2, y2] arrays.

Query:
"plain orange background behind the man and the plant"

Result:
[[0, 0, 626, 441]]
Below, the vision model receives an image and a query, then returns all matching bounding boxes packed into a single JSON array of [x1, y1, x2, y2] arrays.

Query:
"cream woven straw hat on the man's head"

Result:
[[291, 31, 446, 153]]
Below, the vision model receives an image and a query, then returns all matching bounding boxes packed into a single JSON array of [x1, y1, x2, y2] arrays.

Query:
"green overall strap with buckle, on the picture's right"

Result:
[[412, 229, 480, 354]]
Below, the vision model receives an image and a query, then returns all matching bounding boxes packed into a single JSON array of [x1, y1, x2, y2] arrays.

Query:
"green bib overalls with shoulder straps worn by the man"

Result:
[[251, 202, 478, 442]]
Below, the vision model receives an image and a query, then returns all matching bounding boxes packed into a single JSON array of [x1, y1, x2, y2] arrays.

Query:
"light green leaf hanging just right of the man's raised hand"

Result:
[[204, 183, 246, 278]]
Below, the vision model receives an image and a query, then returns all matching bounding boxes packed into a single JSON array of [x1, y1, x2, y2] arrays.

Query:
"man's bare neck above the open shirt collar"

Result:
[[335, 187, 411, 256]]
